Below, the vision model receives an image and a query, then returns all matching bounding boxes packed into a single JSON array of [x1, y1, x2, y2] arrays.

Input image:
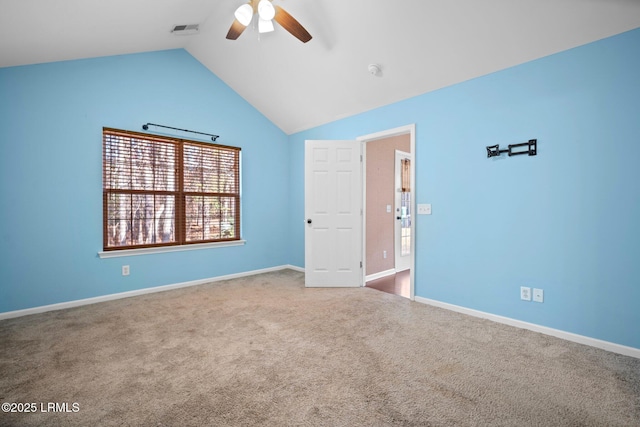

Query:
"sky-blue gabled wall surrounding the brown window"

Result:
[[0, 50, 289, 312]]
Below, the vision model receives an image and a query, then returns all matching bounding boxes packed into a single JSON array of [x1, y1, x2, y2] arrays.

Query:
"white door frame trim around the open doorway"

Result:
[[356, 123, 416, 300]]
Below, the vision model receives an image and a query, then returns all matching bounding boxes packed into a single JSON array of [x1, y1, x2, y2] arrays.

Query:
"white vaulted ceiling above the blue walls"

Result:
[[0, 0, 640, 134]]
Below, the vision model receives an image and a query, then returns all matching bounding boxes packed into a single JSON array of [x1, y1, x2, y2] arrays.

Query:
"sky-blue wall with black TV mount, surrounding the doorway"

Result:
[[289, 29, 640, 348]]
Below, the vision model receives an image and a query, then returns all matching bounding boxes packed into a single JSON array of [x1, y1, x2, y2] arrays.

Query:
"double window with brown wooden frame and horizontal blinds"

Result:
[[102, 128, 240, 251]]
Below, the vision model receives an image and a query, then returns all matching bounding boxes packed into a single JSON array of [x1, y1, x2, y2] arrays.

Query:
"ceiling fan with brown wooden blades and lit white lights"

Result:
[[227, 0, 311, 43]]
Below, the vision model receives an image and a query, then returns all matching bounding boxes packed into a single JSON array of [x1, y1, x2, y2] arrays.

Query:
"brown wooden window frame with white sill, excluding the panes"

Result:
[[99, 127, 244, 252]]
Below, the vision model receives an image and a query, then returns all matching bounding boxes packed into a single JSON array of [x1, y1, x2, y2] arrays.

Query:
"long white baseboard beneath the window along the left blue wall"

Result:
[[0, 265, 304, 320]]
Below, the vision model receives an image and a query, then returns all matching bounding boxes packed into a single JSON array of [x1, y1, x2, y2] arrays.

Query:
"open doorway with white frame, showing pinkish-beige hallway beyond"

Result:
[[357, 125, 415, 299]]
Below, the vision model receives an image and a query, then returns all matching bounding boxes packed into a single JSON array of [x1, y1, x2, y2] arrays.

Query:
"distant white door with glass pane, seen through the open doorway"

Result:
[[394, 150, 413, 272]]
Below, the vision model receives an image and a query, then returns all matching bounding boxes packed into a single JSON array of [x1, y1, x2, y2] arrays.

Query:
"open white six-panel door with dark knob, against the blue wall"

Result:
[[304, 140, 362, 287]]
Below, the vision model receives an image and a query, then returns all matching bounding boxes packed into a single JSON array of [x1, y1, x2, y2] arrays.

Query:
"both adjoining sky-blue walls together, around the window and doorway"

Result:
[[0, 29, 640, 348]]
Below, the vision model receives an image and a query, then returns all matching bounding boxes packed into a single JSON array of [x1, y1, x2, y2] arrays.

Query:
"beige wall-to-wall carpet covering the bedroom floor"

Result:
[[0, 270, 640, 426]]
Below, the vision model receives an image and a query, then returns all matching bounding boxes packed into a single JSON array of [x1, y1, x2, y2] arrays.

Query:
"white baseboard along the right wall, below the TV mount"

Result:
[[416, 296, 640, 359]]
